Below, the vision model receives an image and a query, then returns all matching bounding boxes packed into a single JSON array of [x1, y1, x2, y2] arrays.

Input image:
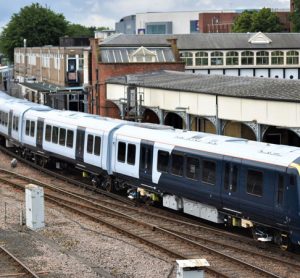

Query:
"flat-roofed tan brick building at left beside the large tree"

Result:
[[14, 41, 90, 111]]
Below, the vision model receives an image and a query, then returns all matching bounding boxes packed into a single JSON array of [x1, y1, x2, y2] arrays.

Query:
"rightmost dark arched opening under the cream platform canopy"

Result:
[[263, 126, 300, 147]]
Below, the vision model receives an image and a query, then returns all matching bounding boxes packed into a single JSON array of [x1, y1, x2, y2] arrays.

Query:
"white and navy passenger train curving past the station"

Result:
[[0, 93, 300, 248]]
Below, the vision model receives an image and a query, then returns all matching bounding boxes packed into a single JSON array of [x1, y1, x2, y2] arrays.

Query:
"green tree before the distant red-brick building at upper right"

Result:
[[232, 8, 283, 33]]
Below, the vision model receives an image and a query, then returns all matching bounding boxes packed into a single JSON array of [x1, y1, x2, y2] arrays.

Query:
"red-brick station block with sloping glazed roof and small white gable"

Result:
[[89, 39, 184, 118]]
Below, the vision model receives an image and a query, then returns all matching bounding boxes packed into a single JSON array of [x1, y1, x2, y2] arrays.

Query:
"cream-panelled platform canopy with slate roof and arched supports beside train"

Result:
[[106, 71, 300, 147]]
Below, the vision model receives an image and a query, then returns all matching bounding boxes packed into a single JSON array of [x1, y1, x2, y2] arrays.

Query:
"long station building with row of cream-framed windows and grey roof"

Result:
[[102, 32, 300, 79]]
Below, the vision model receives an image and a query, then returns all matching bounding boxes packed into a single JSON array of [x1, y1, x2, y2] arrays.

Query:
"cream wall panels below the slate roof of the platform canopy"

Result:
[[107, 84, 300, 127]]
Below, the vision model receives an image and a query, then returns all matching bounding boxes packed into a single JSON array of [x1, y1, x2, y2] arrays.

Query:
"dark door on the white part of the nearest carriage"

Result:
[[139, 142, 153, 186]]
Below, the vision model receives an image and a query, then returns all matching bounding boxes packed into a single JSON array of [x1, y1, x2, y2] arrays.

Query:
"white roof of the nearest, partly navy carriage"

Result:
[[117, 126, 300, 167]]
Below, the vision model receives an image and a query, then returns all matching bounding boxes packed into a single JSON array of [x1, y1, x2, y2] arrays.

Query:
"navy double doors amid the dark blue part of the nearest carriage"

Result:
[[221, 159, 241, 214]]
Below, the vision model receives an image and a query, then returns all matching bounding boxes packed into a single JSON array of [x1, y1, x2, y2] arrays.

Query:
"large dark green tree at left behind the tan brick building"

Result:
[[0, 3, 69, 61]]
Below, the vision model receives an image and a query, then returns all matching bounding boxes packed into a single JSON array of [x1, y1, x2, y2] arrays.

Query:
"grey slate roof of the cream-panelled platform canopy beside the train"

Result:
[[106, 71, 300, 102]]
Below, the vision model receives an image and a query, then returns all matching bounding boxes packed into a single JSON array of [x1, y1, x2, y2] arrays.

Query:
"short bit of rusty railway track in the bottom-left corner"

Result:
[[0, 246, 39, 278]]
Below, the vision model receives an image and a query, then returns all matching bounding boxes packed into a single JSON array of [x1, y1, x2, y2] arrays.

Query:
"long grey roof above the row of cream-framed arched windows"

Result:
[[100, 33, 300, 50]]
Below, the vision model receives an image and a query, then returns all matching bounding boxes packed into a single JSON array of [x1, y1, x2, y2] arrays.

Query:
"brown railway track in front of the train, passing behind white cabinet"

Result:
[[0, 166, 300, 277]]
